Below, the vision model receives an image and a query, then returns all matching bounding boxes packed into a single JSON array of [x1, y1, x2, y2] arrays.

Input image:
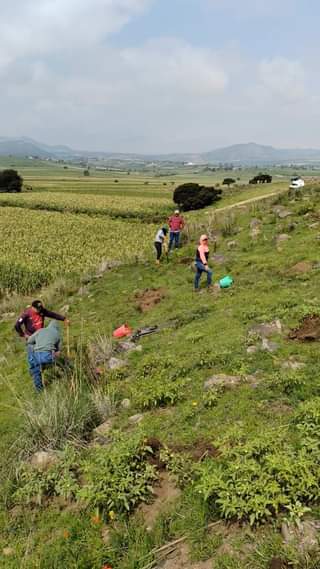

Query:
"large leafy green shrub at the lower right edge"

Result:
[[196, 430, 320, 525]]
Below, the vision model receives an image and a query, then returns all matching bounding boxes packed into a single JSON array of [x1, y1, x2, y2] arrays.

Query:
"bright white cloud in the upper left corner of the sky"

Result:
[[0, 0, 152, 67]]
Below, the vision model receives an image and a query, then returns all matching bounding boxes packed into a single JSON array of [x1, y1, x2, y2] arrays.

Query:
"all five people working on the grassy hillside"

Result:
[[15, 209, 212, 392]]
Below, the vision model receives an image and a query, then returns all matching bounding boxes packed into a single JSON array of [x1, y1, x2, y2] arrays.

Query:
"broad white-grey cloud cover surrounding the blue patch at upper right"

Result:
[[0, 0, 320, 152]]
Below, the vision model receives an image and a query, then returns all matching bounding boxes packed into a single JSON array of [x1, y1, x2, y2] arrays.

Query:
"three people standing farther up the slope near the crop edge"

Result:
[[154, 209, 213, 292]]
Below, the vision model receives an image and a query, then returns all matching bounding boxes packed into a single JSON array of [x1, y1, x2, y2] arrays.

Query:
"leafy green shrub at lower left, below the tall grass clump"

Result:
[[13, 434, 157, 518]]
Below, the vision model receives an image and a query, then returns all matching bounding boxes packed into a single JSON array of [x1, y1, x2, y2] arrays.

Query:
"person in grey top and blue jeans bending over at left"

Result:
[[27, 321, 61, 392]]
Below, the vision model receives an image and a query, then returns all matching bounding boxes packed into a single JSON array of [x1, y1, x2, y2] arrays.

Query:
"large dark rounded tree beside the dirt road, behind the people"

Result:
[[173, 182, 222, 211]]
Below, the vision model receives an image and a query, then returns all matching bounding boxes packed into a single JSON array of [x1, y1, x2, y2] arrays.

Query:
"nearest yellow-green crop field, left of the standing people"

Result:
[[0, 207, 156, 293]]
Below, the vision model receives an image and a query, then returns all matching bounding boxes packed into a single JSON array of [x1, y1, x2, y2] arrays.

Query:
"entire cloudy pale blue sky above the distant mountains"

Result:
[[0, 0, 320, 153]]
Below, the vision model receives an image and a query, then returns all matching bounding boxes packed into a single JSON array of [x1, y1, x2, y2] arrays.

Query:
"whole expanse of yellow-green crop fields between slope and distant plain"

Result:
[[0, 159, 294, 293]]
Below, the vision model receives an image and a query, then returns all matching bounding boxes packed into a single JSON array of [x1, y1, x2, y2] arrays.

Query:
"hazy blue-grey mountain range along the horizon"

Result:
[[0, 137, 320, 165]]
